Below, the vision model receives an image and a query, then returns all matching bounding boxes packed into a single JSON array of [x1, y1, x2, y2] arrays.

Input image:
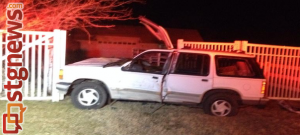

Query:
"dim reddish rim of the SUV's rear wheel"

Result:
[[211, 100, 232, 116]]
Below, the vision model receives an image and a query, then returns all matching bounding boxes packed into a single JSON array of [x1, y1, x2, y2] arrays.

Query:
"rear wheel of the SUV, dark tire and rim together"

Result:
[[204, 93, 238, 116]]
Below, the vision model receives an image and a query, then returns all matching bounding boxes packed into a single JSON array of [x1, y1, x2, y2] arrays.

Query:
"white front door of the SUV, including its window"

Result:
[[117, 51, 171, 102]]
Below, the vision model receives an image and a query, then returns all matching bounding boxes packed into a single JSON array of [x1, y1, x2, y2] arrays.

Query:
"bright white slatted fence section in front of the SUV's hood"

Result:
[[0, 30, 66, 101]]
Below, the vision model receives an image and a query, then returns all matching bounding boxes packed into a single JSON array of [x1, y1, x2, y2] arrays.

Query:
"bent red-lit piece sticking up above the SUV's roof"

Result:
[[139, 16, 174, 49]]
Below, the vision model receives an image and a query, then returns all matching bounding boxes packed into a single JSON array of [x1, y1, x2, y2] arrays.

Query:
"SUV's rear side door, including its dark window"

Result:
[[163, 53, 212, 103]]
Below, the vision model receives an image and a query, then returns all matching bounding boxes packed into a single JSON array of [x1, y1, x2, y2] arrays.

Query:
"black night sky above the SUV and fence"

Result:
[[128, 0, 300, 46]]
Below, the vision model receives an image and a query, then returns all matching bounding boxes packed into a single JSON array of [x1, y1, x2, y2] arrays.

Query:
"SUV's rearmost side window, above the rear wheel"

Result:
[[216, 56, 258, 77]]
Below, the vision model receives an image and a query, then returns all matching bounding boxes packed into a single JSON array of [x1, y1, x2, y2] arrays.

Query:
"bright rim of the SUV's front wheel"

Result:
[[78, 89, 100, 106]]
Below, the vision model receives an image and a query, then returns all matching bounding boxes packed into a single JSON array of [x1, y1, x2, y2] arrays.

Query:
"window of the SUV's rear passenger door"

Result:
[[174, 53, 210, 76]]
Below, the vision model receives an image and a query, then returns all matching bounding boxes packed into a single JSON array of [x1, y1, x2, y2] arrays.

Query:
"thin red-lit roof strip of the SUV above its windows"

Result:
[[145, 49, 255, 58]]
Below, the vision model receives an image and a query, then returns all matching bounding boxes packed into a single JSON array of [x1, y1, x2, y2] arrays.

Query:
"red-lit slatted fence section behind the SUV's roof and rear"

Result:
[[177, 39, 300, 100]]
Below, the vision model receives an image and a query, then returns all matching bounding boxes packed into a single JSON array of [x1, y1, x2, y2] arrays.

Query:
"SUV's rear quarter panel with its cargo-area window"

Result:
[[213, 55, 265, 100]]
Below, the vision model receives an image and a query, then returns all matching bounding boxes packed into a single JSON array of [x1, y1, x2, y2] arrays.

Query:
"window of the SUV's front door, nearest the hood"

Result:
[[123, 52, 170, 74]]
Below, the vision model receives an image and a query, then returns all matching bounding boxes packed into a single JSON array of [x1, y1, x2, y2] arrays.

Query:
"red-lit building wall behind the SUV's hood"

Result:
[[79, 36, 159, 58]]
